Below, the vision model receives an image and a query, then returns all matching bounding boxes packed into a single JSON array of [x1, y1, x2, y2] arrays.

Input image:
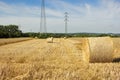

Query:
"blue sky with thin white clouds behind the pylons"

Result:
[[0, 0, 120, 33]]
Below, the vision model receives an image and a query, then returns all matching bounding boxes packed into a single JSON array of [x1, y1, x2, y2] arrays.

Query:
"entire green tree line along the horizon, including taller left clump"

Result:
[[0, 25, 120, 38]]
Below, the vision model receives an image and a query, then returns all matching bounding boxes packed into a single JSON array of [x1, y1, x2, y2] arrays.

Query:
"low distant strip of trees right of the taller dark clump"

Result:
[[24, 32, 120, 38]]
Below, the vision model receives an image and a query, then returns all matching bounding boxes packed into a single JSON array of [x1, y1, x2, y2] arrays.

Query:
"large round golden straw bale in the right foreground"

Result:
[[88, 37, 114, 63]]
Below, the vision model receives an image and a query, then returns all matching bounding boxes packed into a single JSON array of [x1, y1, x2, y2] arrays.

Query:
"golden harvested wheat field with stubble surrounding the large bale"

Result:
[[0, 38, 120, 80]]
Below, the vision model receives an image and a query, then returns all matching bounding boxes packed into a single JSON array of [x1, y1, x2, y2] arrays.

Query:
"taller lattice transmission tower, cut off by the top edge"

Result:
[[40, 0, 47, 33]]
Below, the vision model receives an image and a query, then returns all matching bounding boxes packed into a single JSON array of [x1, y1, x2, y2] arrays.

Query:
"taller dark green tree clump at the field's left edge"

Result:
[[0, 25, 22, 38]]
